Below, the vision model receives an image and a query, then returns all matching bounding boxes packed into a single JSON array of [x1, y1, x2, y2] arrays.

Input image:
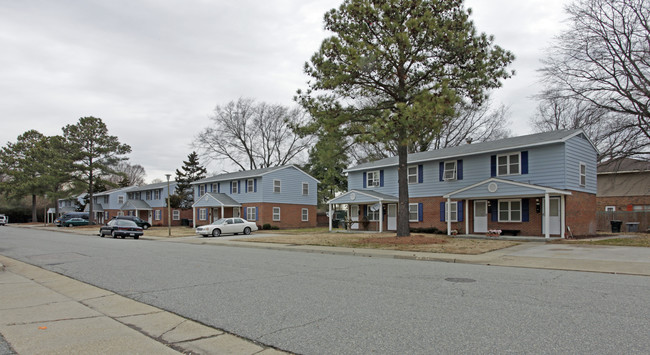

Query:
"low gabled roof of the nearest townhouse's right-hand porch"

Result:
[[442, 178, 571, 199]]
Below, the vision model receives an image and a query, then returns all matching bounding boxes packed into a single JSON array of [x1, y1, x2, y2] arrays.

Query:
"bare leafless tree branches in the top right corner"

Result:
[[541, 0, 650, 140]]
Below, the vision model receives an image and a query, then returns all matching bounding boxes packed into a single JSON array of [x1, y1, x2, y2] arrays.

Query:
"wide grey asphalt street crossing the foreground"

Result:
[[0, 228, 650, 354]]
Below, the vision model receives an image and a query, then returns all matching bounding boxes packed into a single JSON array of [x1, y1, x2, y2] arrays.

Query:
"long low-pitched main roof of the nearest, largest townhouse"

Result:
[[343, 129, 597, 172]]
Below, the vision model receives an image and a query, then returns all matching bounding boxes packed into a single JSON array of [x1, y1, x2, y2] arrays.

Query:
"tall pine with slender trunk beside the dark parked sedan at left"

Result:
[[63, 116, 131, 223]]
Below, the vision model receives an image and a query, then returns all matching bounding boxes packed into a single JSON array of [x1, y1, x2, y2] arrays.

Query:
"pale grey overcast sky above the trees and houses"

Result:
[[0, 0, 568, 182]]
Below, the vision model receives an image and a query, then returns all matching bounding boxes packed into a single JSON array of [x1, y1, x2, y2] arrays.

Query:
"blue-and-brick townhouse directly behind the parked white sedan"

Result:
[[192, 165, 318, 228]]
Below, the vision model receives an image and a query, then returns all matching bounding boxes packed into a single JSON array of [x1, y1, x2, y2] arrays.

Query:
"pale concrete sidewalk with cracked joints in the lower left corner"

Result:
[[0, 256, 285, 355]]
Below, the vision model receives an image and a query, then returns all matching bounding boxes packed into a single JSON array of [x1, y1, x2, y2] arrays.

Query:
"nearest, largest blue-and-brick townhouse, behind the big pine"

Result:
[[328, 130, 597, 238]]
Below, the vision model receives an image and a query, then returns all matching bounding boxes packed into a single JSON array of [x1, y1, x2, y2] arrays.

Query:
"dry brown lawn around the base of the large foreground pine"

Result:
[[240, 231, 519, 255]]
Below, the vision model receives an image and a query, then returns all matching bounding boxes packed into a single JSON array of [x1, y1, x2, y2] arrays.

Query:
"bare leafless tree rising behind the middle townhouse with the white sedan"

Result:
[[194, 98, 312, 170]]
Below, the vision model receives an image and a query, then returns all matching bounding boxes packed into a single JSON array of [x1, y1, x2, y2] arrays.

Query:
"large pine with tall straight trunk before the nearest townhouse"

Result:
[[297, 0, 514, 236]]
